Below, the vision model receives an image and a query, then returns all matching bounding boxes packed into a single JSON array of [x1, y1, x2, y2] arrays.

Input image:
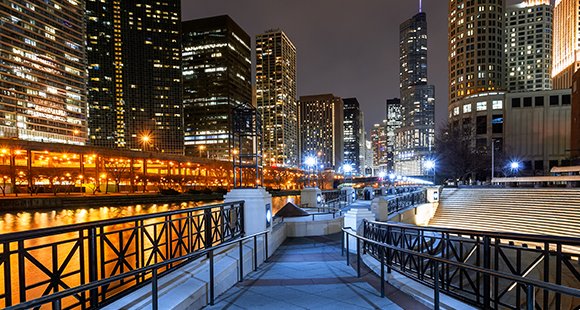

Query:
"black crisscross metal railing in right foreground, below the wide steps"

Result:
[[363, 221, 580, 310]]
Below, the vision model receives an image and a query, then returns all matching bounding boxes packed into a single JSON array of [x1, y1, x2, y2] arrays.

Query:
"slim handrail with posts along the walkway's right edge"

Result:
[[342, 227, 580, 310]]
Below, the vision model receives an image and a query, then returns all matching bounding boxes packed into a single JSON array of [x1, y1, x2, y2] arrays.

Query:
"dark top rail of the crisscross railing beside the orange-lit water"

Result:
[[0, 200, 244, 243]]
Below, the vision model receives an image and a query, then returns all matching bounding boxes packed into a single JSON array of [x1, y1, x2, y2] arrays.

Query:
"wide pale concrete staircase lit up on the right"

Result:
[[429, 188, 580, 238]]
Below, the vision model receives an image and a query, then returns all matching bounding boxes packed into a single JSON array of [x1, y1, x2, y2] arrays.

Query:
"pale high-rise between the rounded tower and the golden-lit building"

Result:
[[505, 0, 553, 92]]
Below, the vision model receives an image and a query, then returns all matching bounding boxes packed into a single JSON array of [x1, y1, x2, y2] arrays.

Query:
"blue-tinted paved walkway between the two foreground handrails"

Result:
[[204, 233, 429, 310]]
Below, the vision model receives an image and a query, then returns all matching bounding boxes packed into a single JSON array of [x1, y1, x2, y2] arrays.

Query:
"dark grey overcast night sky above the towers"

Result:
[[182, 0, 523, 138]]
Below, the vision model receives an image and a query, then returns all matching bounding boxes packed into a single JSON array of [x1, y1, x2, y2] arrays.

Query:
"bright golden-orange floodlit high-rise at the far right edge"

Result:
[[552, 0, 580, 89]]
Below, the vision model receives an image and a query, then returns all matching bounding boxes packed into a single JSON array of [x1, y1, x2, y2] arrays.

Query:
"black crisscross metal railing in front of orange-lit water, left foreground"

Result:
[[0, 201, 244, 309]]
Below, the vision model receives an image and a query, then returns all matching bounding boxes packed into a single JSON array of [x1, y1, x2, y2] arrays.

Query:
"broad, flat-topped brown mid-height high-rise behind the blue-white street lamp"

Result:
[[298, 94, 344, 170]]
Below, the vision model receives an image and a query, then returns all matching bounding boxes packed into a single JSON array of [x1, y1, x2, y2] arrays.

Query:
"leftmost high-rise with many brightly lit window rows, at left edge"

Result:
[[0, 0, 87, 145]]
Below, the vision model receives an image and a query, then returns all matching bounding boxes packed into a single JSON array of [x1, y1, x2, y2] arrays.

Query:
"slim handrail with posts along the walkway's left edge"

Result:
[[5, 230, 269, 310]]
